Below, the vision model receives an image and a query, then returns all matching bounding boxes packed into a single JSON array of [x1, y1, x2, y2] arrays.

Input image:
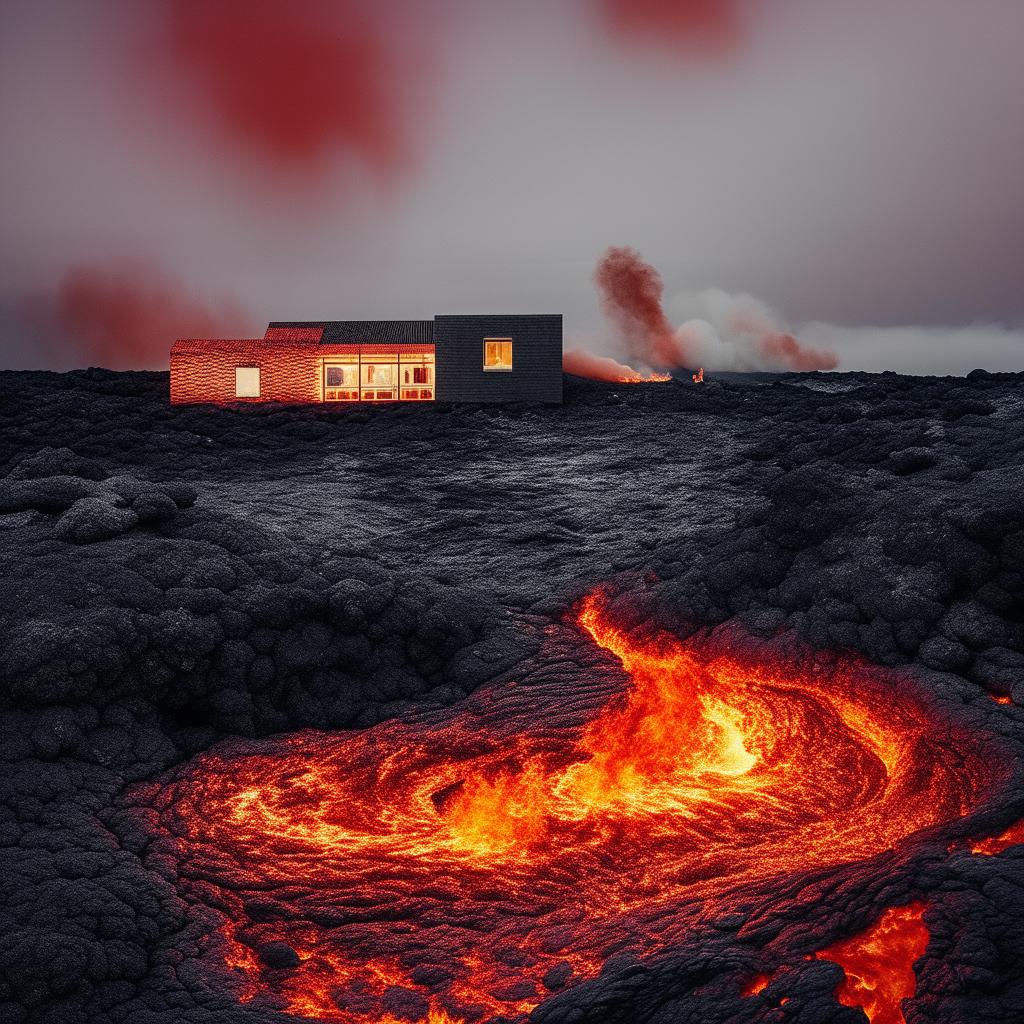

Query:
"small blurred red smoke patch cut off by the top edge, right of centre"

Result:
[[600, 0, 740, 51]]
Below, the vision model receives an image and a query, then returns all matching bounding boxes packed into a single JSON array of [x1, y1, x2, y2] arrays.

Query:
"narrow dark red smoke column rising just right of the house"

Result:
[[594, 246, 686, 367]]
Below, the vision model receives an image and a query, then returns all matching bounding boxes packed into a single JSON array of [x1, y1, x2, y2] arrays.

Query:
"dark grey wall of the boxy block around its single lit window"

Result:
[[434, 314, 562, 402]]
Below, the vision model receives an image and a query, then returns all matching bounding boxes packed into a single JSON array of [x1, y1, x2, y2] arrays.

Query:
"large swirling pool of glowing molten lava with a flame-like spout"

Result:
[[139, 593, 1002, 1024]]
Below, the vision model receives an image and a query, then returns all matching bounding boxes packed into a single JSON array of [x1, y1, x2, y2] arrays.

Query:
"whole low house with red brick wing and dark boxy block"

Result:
[[171, 314, 562, 404]]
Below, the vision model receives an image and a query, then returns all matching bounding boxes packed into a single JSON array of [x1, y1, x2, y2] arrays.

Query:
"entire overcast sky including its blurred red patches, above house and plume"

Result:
[[0, 0, 1024, 372]]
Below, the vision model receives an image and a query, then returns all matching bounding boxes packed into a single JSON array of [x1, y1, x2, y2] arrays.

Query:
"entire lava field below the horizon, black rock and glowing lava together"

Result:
[[0, 370, 1024, 1024]]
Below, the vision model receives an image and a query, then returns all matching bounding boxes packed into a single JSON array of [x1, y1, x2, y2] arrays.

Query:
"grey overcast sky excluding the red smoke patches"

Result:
[[0, 0, 1024, 372]]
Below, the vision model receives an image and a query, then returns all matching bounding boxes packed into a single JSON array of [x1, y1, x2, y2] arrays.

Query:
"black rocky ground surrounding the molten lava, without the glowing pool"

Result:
[[0, 370, 1024, 1024]]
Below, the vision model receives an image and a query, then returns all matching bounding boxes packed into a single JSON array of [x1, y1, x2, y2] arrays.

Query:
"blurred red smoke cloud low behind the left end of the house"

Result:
[[23, 264, 252, 370]]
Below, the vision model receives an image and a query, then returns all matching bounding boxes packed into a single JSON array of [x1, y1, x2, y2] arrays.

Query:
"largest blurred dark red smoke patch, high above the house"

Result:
[[160, 0, 416, 174]]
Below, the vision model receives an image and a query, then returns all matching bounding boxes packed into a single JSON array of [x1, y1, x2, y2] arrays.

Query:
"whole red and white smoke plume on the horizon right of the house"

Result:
[[572, 246, 839, 380]]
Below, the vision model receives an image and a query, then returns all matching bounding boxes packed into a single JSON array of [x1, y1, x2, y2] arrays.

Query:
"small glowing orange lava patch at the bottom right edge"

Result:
[[817, 903, 928, 1024]]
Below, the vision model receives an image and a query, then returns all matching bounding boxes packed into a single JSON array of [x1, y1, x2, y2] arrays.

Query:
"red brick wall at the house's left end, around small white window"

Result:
[[171, 339, 322, 406]]
